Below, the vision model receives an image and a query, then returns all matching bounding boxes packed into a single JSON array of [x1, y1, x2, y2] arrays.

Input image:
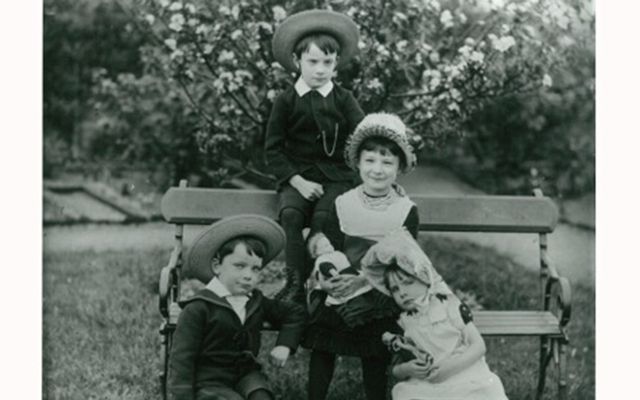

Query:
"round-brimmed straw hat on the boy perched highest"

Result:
[[272, 10, 360, 71]]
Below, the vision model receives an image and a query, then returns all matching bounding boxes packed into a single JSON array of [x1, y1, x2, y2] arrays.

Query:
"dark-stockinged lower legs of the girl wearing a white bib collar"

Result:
[[309, 350, 388, 400]]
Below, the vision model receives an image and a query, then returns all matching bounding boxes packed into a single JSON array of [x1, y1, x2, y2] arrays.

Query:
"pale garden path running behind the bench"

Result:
[[43, 166, 595, 285]]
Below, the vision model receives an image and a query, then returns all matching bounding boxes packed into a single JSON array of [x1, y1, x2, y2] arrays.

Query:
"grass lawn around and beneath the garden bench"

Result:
[[43, 237, 595, 400]]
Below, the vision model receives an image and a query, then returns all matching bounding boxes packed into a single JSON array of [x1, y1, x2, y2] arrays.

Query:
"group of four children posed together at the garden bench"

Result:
[[169, 10, 506, 400]]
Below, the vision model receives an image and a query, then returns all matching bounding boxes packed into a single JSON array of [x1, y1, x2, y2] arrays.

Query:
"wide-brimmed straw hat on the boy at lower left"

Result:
[[185, 214, 285, 283]]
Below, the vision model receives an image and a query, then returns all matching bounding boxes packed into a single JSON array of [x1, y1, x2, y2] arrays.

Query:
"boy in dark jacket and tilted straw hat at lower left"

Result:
[[169, 215, 305, 400]]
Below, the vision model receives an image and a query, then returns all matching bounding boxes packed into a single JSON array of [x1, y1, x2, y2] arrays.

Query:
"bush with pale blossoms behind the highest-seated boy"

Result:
[[91, 0, 594, 193]]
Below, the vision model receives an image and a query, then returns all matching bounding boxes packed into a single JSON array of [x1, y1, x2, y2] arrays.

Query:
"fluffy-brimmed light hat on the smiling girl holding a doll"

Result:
[[344, 113, 418, 174]]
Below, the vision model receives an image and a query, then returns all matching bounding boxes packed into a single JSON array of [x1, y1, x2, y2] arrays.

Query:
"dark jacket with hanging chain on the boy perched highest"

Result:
[[265, 84, 364, 185]]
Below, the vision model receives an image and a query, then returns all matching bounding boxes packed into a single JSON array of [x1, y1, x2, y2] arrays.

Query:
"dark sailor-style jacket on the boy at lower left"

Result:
[[169, 289, 305, 400]]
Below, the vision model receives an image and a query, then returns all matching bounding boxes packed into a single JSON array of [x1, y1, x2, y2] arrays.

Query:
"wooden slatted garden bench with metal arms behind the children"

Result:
[[159, 181, 571, 399]]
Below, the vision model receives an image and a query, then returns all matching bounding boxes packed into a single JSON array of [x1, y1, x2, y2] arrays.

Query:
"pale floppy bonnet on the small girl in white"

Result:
[[361, 228, 451, 296]]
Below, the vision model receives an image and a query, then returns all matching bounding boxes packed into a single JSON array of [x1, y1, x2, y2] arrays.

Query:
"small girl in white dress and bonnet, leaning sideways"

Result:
[[362, 230, 507, 400]]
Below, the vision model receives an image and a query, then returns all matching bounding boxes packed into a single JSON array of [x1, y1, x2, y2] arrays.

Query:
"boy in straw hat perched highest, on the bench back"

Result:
[[265, 10, 364, 303]]
